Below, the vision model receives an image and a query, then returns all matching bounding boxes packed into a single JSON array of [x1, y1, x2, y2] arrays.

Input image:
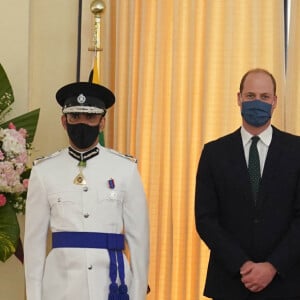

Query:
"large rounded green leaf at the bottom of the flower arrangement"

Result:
[[0, 203, 20, 262]]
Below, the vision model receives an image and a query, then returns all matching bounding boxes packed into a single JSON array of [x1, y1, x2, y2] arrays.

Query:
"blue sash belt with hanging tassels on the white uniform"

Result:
[[52, 231, 129, 300]]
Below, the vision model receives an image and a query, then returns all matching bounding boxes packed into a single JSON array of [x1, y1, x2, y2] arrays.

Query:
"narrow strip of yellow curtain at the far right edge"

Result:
[[285, 0, 300, 135]]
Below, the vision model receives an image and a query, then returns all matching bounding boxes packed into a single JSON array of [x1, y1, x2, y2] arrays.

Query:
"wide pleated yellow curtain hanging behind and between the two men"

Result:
[[101, 0, 286, 300]]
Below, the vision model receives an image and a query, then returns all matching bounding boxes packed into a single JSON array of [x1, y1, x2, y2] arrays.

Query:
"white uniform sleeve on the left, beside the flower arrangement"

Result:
[[24, 167, 50, 300]]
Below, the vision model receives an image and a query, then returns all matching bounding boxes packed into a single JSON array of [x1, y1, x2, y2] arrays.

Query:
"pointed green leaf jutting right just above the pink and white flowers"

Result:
[[0, 108, 40, 143]]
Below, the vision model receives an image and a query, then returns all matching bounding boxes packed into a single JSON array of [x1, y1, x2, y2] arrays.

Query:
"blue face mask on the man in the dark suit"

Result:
[[241, 100, 272, 127]]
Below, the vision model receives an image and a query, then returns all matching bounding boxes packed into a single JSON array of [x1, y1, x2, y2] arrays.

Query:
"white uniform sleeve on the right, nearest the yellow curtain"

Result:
[[124, 164, 149, 300]]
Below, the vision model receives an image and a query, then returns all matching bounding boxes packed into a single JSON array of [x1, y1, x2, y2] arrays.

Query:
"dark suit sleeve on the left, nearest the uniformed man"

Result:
[[195, 145, 249, 276]]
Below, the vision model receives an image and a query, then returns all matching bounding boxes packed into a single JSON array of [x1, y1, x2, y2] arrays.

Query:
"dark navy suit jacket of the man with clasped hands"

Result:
[[195, 127, 300, 299]]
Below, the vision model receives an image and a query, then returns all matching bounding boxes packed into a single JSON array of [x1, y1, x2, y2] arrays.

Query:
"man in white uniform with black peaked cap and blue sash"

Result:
[[24, 82, 149, 300]]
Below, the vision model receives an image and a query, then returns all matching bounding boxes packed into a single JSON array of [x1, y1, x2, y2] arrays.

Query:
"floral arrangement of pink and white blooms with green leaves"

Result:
[[0, 64, 39, 262]]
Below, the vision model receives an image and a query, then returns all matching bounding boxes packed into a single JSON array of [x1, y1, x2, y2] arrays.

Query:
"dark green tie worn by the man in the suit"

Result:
[[248, 136, 260, 199]]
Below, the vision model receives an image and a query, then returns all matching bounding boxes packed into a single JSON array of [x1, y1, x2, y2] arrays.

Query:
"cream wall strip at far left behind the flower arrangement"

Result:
[[0, 0, 30, 300]]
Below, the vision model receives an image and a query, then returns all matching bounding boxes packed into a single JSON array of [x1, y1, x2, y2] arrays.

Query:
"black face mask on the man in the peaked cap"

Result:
[[67, 123, 99, 149]]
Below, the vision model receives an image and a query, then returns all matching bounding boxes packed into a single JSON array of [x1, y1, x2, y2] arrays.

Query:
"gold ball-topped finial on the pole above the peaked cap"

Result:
[[89, 0, 105, 53]]
